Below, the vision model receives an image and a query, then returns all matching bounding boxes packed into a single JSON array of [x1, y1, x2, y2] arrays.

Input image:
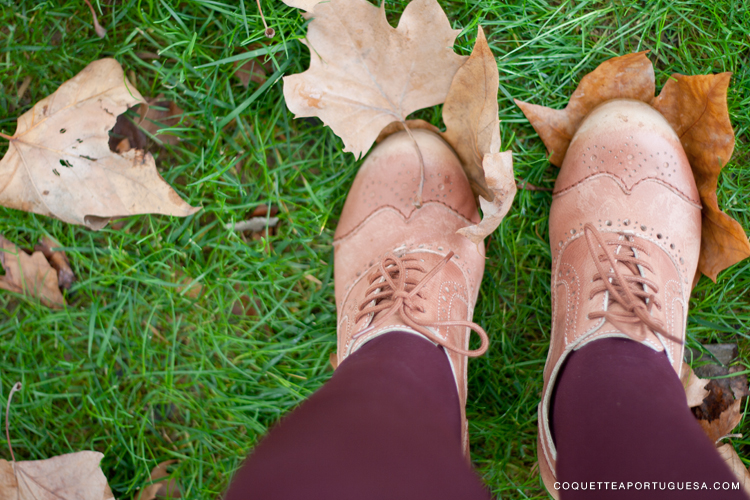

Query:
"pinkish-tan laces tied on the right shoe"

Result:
[[583, 223, 682, 344]]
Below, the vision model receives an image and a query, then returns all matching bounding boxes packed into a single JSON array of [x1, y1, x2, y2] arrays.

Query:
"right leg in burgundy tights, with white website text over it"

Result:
[[552, 339, 746, 500]]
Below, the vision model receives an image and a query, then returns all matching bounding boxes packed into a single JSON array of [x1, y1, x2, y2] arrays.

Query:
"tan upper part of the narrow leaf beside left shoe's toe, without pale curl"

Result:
[[442, 26, 502, 201]]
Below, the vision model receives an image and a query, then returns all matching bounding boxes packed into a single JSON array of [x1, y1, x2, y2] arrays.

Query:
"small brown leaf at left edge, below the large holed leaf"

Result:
[[0, 235, 65, 309]]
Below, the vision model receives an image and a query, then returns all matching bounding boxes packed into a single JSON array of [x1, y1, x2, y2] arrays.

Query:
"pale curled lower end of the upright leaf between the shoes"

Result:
[[458, 151, 516, 245]]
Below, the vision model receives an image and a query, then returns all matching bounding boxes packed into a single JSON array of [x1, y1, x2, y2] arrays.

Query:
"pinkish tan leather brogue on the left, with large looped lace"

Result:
[[333, 130, 488, 453]]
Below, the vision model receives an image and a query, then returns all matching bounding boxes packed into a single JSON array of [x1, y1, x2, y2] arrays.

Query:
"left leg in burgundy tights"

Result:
[[226, 333, 489, 500]]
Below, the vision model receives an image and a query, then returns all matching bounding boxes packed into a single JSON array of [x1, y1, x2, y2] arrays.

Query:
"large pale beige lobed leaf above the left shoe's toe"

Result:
[[284, 0, 466, 158]]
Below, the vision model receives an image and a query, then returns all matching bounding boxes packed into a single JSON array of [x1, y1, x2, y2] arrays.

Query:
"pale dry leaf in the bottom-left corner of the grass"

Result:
[[0, 451, 114, 500]]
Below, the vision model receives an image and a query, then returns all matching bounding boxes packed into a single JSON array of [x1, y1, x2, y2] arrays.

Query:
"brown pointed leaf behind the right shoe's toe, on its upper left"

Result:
[[516, 52, 656, 167]]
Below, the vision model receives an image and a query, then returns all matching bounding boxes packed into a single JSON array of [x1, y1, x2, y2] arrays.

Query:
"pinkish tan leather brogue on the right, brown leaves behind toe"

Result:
[[538, 100, 701, 498]]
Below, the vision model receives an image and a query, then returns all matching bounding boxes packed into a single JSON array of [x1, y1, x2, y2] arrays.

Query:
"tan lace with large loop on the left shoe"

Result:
[[353, 252, 489, 357]]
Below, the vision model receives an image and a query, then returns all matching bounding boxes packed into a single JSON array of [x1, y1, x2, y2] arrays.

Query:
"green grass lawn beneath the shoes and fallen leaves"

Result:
[[0, 0, 750, 498]]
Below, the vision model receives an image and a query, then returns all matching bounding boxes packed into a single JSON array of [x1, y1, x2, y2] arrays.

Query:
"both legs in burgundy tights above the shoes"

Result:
[[226, 332, 744, 500]]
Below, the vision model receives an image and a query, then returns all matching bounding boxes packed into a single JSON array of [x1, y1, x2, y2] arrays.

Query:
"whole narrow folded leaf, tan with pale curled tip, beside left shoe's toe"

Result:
[[442, 27, 516, 245]]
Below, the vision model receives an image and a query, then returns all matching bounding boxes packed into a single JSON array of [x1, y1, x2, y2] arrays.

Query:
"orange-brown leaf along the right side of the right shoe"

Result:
[[654, 73, 750, 281]]
